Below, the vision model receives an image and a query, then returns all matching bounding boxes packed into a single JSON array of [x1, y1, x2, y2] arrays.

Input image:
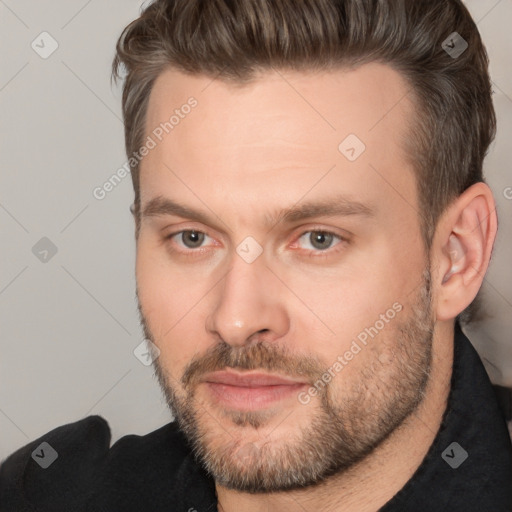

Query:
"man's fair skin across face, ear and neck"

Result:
[[132, 63, 496, 512]]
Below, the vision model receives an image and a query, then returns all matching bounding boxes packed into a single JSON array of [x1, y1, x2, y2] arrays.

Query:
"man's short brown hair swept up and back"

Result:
[[113, 0, 496, 320]]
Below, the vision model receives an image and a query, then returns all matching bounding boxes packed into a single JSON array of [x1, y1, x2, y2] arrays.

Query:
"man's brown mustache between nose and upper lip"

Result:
[[181, 341, 325, 389]]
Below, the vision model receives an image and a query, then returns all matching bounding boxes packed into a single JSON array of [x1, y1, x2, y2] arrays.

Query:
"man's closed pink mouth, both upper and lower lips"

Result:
[[201, 370, 308, 411]]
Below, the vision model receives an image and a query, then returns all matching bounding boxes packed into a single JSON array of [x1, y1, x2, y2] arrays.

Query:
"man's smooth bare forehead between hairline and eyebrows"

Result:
[[141, 63, 415, 224]]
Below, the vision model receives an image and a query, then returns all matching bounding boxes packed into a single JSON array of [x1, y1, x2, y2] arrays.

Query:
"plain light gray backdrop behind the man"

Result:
[[0, 0, 512, 459]]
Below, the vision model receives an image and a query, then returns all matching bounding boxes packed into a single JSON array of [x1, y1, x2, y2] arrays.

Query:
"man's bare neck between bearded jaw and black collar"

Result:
[[216, 322, 454, 512]]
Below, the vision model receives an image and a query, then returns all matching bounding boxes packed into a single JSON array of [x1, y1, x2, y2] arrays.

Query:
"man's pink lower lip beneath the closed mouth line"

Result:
[[205, 382, 307, 411]]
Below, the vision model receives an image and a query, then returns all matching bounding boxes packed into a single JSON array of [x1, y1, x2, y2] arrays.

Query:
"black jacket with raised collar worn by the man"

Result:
[[0, 326, 512, 512]]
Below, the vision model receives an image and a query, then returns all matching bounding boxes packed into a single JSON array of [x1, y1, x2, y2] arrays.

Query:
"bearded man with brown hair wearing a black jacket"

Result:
[[0, 0, 512, 512]]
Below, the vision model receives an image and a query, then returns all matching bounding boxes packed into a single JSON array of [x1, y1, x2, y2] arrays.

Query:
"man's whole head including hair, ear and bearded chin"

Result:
[[114, 0, 496, 492]]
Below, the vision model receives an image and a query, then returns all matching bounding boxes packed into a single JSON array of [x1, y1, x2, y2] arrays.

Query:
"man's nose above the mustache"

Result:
[[206, 248, 290, 346]]
